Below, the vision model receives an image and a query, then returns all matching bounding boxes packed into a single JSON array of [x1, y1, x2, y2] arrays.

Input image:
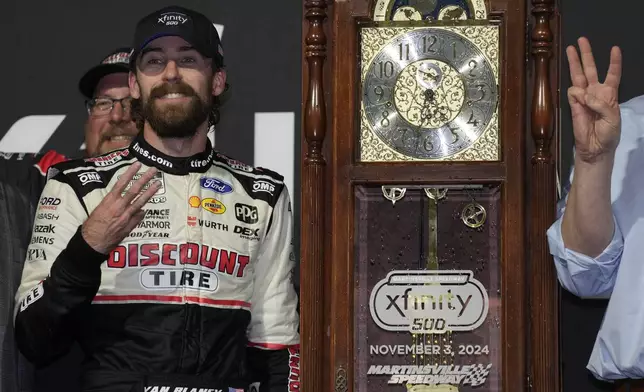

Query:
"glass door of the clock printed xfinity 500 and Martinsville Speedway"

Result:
[[353, 184, 502, 392]]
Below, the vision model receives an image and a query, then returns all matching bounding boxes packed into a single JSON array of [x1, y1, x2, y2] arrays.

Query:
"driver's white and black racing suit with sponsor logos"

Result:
[[15, 135, 299, 392]]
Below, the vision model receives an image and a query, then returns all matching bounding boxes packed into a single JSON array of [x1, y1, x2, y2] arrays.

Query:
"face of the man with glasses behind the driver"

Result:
[[85, 72, 138, 157]]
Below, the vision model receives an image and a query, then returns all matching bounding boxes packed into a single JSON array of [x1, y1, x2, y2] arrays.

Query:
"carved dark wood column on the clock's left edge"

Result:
[[300, 0, 327, 391]]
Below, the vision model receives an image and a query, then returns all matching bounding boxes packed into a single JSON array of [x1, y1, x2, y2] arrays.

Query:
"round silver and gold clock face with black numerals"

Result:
[[362, 28, 498, 160]]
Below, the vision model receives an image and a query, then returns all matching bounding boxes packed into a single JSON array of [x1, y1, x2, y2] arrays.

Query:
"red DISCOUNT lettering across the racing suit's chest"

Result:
[[107, 243, 250, 278]]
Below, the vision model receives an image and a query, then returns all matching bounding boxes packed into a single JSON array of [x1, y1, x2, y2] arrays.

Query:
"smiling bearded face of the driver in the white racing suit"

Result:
[[130, 37, 225, 138]]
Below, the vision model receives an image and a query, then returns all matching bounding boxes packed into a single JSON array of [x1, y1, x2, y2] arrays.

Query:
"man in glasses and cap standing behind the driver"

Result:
[[0, 48, 137, 392]]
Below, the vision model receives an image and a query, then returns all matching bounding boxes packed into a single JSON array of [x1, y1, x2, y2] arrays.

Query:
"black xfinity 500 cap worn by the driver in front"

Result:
[[130, 6, 224, 69]]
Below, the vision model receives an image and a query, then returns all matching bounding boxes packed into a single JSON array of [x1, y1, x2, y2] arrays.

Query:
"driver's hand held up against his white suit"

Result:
[[81, 162, 161, 254]]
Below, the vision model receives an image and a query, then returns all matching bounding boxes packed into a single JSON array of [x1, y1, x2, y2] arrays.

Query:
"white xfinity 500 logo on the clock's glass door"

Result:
[[369, 271, 490, 333]]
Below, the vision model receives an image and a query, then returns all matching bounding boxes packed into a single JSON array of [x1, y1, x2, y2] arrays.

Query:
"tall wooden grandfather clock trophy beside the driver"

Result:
[[301, 0, 559, 392]]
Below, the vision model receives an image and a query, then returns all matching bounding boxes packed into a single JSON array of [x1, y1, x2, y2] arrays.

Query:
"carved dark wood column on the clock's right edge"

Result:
[[528, 0, 560, 392]]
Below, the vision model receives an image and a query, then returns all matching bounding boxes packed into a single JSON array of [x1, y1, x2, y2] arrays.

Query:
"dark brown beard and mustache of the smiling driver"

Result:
[[142, 83, 211, 138]]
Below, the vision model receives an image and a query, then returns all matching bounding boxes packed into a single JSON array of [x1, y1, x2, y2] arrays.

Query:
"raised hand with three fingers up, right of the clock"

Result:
[[566, 37, 622, 163]]
